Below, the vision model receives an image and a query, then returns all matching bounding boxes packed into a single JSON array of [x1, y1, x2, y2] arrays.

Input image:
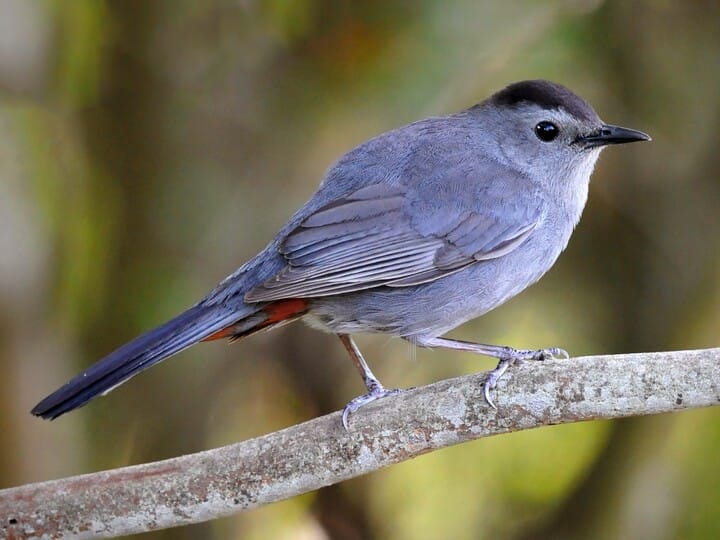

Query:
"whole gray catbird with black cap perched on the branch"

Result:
[[32, 80, 650, 429]]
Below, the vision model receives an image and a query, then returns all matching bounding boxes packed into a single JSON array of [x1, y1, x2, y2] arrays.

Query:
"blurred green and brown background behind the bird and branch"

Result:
[[0, 0, 720, 540]]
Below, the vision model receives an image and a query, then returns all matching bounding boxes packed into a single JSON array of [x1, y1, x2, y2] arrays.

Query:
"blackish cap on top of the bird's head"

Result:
[[489, 79, 599, 122]]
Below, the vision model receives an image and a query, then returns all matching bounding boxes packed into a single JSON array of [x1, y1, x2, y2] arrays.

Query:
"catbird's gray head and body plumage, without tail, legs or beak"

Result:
[[219, 81, 620, 338]]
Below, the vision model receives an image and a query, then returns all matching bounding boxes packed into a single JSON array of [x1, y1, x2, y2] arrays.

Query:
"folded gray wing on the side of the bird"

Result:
[[245, 178, 540, 302]]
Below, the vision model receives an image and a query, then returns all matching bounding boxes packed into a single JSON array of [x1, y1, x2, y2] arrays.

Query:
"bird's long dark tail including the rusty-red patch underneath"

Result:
[[31, 300, 305, 420]]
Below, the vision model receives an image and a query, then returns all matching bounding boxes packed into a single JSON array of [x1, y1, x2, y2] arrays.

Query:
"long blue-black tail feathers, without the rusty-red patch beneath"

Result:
[[31, 305, 255, 419]]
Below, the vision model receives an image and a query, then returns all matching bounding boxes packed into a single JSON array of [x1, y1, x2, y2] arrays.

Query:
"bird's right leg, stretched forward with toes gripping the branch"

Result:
[[414, 337, 570, 409]]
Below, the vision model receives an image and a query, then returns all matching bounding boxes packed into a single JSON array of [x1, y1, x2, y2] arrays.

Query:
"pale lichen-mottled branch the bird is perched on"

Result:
[[0, 349, 720, 538]]
